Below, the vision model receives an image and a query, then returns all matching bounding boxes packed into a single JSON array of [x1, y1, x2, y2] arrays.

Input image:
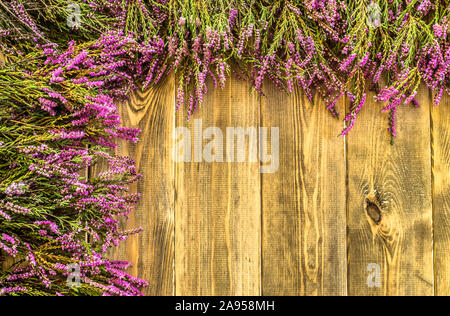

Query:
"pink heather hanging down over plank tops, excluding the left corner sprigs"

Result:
[[109, 0, 449, 135]]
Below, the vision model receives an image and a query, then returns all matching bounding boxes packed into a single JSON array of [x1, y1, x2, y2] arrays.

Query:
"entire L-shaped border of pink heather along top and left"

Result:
[[0, 0, 450, 295]]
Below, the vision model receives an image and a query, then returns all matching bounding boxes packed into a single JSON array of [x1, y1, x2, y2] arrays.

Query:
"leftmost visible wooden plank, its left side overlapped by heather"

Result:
[[106, 76, 175, 296]]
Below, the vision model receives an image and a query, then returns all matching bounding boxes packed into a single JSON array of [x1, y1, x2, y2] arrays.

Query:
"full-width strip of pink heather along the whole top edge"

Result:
[[0, 0, 450, 136]]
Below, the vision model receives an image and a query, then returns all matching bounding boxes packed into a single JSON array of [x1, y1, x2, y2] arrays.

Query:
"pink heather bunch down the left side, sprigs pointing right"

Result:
[[0, 43, 146, 295]]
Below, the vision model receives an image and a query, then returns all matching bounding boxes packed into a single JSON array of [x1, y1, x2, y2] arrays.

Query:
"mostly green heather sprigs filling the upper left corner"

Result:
[[0, 0, 118, 50]]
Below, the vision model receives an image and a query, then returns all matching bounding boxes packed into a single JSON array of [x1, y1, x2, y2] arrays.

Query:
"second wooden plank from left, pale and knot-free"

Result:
[[175, 78, 261, 296]]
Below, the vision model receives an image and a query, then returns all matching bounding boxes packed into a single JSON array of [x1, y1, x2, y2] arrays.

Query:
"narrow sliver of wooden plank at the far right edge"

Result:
[[430, 91, 450, 296]]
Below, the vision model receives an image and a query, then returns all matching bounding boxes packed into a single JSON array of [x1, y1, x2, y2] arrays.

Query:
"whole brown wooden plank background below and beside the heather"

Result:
[[1, 77, 450, 296]]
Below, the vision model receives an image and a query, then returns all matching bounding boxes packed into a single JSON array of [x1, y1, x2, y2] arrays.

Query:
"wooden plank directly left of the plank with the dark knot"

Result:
[[262, 85, 347, 295]]
